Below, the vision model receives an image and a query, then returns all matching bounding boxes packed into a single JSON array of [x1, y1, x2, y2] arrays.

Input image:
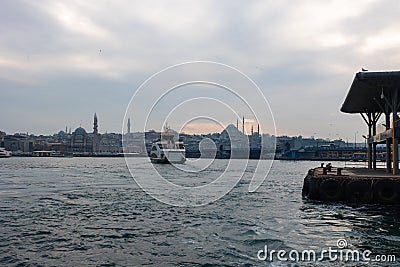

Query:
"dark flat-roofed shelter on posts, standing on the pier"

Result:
[[341, 71, 400, 174]]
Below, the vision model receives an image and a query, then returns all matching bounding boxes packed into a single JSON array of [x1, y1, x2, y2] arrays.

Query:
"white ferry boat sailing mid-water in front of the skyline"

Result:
[[150, 126, 186, 163]]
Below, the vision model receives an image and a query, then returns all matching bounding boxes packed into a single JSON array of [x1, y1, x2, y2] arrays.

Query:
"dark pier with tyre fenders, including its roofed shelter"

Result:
[[302, 71, 400, 204]]
